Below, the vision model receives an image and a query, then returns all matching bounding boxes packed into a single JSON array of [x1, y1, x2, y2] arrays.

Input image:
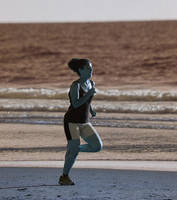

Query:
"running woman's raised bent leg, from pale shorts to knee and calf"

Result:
[[80, 123, 103, 152]]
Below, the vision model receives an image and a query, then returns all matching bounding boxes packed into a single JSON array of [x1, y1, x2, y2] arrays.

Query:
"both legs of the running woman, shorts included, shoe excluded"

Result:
[[63, 123, 103, 175]]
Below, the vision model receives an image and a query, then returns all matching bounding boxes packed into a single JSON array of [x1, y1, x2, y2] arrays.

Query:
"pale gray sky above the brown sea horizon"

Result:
[[0, 0, 177, 23]]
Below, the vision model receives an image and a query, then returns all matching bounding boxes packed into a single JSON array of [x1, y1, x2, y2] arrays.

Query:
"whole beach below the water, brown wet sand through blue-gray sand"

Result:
[[0, 112, 177, 200]]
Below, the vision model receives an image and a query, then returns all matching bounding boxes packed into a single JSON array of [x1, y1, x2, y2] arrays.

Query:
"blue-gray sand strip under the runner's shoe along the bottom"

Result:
[[0, 168, 177, 200]]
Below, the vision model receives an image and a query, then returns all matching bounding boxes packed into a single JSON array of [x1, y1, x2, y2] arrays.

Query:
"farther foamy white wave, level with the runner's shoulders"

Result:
[[0, 88, 177, 101]]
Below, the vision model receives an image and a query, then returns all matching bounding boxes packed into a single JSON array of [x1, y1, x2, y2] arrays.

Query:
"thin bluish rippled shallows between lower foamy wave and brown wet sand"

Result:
[[0, 112, 177, 130]]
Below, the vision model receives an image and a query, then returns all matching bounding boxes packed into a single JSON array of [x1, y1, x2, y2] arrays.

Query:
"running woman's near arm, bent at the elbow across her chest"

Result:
[[70, 82, 95, 108]]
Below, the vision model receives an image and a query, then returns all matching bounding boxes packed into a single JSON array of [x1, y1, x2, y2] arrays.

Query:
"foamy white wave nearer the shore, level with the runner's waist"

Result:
[[0, 99, 177, 114]]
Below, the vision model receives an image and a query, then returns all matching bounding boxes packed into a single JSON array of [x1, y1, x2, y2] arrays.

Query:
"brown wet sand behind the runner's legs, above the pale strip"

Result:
[[0, 113, 177, 161]]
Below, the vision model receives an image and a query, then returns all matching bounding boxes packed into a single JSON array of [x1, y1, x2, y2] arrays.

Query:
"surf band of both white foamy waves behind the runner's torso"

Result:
[[0, 88, 177, 113]]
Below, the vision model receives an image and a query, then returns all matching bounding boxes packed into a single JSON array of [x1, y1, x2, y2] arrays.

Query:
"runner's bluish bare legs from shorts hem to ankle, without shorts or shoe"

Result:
[[63, 132, 103, 175]]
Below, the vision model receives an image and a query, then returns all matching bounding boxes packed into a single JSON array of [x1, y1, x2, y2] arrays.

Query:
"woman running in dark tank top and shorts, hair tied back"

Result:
[[59, 58, 103, 185]]
